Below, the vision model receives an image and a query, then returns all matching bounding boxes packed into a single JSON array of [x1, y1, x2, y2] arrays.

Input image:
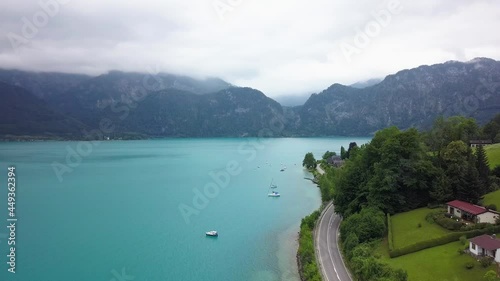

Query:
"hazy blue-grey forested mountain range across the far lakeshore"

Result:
[[0, 58, 500, 139]]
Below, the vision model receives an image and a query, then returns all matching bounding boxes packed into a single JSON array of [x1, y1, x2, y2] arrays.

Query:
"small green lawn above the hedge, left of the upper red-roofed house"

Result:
[[391, 208, 451, 248]]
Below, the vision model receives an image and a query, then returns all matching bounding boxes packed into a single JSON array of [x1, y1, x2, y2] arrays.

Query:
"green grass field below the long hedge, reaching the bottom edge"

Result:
[[375, 238, 495, 281]]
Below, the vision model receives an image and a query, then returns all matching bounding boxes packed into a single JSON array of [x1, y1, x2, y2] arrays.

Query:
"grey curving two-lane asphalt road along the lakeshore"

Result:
[[314, 203, 352, 281]]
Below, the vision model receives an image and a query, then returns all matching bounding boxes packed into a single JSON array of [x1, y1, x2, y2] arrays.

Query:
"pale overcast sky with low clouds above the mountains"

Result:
[[0, 0, 500, 97]]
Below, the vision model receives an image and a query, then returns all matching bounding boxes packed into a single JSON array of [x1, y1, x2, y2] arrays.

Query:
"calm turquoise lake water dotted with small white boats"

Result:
[[0, 137, 369, 281]]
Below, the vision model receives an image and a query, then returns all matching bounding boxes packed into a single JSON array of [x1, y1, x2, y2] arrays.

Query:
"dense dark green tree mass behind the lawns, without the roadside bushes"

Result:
[[333, 117, 491, 217]]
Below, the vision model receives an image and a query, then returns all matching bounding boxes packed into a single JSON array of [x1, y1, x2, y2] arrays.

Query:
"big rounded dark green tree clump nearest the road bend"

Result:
[[334, 127, 437, 216]]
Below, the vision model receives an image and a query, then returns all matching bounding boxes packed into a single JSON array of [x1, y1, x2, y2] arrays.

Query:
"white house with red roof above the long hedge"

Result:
[[446, 200, 500, 224]]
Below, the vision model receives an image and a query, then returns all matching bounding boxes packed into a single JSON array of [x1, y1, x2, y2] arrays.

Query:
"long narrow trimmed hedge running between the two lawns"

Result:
[[389, 225, 500, 258]]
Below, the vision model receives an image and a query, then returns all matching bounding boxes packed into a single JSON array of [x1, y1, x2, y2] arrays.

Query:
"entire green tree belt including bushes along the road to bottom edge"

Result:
[[319, 115, 500, 281]]
